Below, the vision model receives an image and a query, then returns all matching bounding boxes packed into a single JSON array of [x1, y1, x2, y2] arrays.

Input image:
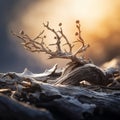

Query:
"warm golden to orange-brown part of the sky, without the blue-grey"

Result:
[[12, 0, 120, 64]]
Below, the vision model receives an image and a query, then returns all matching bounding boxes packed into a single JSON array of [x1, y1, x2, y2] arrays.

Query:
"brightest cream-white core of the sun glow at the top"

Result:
[[59, 0, 110, 29]]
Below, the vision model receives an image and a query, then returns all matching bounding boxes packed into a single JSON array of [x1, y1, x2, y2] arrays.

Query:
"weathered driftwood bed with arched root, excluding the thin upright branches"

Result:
[[0, 61, 120, 120]]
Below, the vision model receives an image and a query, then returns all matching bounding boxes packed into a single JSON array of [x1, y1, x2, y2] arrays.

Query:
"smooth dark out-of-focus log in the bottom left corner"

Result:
[[0, 94, 54, 120]]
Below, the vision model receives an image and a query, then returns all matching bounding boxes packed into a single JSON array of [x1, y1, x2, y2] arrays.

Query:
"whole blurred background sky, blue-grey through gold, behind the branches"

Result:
[[0, 0, 120, 72]]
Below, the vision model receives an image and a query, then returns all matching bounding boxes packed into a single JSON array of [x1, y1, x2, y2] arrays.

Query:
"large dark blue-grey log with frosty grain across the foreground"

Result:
[[11, 83, 120, 120]]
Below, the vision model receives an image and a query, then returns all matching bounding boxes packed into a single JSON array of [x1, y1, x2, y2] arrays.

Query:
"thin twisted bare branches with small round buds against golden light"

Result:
[[13, 20, 90, 64]]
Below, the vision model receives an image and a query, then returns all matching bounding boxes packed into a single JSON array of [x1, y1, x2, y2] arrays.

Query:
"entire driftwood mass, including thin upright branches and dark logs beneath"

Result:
[[8, 20, 120, 120]]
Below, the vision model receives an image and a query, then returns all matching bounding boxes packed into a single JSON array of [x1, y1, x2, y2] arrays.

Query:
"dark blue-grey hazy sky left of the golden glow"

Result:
[[0, 0, 42, 72]]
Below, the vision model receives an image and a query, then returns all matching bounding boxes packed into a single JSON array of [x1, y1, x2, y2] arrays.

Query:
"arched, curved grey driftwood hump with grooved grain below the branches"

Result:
[[55, 64, 112, 85]]
